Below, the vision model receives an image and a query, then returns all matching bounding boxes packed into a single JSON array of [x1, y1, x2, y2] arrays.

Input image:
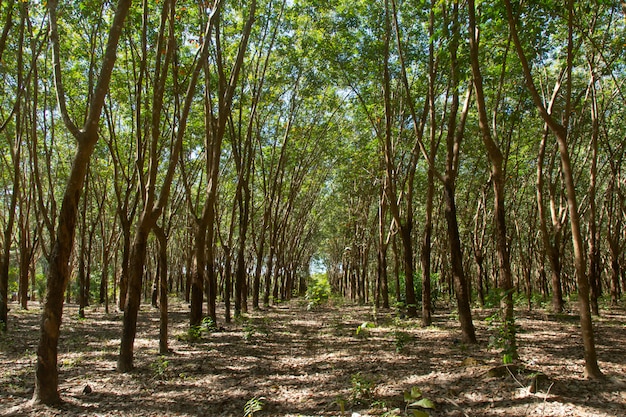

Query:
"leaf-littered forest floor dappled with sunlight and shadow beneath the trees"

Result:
[[0, 301, 626, 417]]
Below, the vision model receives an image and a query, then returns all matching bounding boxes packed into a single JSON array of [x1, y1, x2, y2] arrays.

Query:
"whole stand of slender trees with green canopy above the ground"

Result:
[[0, 0, 626, 403]]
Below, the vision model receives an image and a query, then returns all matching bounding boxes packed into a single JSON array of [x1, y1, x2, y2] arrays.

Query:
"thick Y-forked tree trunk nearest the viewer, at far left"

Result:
[[33, 0, 131, 404]]
